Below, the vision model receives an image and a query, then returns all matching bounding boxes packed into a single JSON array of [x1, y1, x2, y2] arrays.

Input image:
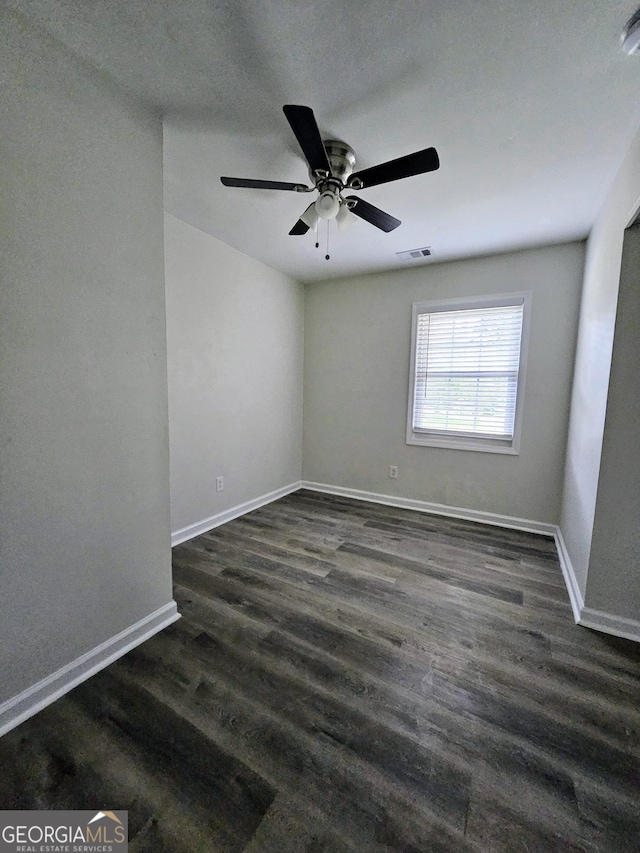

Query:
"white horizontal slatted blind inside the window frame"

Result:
[[413, 301, 523, 439]]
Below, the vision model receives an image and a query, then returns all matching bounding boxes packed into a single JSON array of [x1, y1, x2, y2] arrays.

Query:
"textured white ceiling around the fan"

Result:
[[10, 0, 640, 281]]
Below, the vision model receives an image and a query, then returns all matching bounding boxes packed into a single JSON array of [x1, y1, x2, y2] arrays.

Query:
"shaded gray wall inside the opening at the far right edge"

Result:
[[585, 225, 640, 620]]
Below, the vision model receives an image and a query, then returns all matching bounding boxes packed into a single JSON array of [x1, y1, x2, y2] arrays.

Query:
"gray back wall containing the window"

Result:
[[303, 243, 584, 523]]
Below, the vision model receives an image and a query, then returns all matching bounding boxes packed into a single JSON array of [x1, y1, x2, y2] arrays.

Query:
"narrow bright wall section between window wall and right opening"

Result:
[[560, 123, 640, 596]]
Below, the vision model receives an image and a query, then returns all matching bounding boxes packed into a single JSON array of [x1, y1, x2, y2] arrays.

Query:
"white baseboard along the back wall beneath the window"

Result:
[[300, 480, 556, 536]]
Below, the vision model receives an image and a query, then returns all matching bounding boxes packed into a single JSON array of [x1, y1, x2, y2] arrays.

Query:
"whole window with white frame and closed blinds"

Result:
[[407, 292, 531, 453]]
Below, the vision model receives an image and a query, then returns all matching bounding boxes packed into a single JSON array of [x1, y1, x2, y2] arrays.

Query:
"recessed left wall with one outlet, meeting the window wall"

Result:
[[165, 215, 304, 532]]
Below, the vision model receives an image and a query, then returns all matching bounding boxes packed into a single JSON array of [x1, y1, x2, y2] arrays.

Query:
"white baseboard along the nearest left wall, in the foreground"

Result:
[[0, 601, 180, 737]]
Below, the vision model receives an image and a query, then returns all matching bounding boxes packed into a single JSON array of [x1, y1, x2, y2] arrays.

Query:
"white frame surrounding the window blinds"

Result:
[[407, 290, 532, 455]]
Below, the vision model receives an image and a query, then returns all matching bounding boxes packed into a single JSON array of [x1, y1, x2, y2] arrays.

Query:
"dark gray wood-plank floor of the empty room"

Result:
[[0, 491, 640, 853]]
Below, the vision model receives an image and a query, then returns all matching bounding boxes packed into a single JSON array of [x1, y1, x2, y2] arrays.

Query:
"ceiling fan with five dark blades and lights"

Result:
[[220, 104, 440, 241]]
